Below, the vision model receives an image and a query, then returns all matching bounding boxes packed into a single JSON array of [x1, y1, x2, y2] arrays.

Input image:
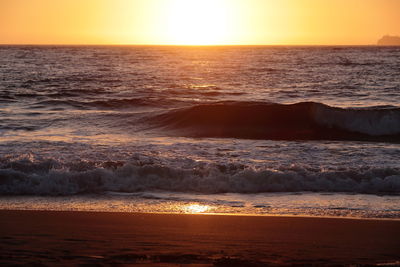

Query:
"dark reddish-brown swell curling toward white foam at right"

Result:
[[154, 102, 400, 142]]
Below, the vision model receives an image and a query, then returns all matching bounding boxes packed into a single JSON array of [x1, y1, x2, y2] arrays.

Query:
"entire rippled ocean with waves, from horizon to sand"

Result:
[[0, 46, 400, 219]]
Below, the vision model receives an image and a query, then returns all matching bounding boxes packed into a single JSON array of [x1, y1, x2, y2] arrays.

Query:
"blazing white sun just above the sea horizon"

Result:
[[165, 0, 231, 45]]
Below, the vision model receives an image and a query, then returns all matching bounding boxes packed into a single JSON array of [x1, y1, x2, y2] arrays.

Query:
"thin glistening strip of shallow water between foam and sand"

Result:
[[0, 192, 400, 221]]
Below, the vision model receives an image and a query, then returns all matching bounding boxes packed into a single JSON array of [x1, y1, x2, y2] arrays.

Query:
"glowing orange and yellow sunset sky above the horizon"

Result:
[[0, 0, 400, 45]]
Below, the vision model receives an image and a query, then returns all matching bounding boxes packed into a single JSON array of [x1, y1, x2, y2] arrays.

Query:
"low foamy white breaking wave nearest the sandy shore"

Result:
[[0, 160, 400, 195]]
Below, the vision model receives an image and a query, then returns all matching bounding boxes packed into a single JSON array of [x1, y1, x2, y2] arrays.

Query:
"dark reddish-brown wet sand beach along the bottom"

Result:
[[0, 211, 400, 266]]
